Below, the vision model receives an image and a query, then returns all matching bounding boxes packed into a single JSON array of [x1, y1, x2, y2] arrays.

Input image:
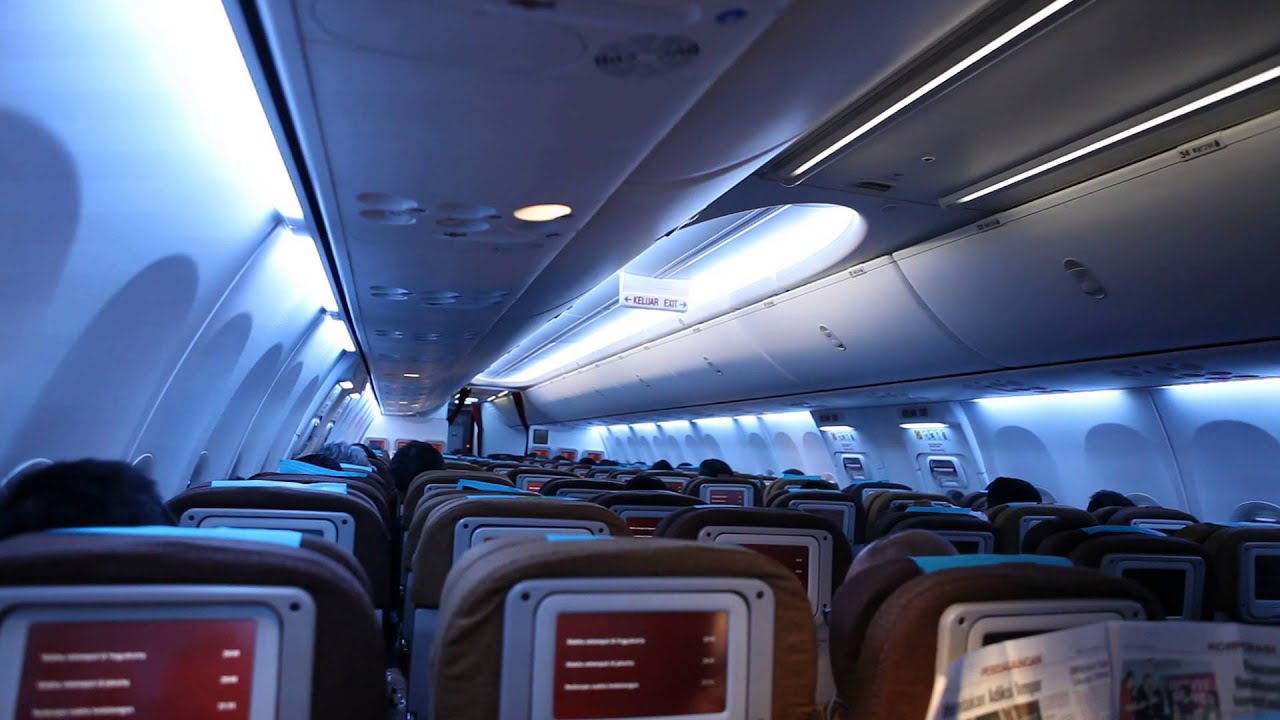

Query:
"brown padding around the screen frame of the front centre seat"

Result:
[[433, 538, 817, 720]]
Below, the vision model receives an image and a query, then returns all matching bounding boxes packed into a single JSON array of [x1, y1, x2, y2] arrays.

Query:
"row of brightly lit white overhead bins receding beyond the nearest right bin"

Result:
[[526, 258, 995, 420]]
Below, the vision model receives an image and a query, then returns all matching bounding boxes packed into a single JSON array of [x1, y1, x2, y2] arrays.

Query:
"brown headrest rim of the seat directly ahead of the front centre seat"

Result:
[[412, 496, 631, 607]]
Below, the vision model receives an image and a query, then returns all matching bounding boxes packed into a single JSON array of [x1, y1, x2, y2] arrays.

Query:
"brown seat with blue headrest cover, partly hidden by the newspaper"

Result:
[[831, 555, 1161, 720]]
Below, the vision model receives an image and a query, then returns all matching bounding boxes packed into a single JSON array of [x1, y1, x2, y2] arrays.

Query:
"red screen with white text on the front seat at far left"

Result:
[[18, 620, 257, 720]]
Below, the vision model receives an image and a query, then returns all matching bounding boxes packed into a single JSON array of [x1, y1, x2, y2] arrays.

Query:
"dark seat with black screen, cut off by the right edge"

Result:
[[1202, 523, 1280, 625]]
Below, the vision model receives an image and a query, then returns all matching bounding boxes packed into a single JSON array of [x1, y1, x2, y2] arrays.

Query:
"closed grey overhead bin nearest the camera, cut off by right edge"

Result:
[[895, 114, 1280, 366]]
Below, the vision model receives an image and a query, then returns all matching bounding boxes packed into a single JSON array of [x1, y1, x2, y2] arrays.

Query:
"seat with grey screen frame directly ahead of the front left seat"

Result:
[[168, 484, 396, 610]]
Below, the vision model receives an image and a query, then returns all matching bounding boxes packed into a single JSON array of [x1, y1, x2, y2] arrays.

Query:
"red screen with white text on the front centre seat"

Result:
[[553, 611, 728, 720]]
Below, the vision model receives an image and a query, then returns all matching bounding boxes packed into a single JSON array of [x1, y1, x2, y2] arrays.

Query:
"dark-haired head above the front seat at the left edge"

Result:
[[0, 460, 174, 538]]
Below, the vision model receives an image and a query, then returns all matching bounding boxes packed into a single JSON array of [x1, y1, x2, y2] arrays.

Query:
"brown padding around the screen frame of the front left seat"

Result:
[[0, 533, 387, 720]]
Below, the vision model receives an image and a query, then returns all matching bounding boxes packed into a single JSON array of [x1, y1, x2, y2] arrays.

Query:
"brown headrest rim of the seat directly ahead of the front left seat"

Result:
[[168, 487, 390, 607]]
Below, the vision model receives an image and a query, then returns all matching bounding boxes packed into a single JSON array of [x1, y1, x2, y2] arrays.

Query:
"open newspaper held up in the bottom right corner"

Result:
[[928, 621, 1280, 720]]
